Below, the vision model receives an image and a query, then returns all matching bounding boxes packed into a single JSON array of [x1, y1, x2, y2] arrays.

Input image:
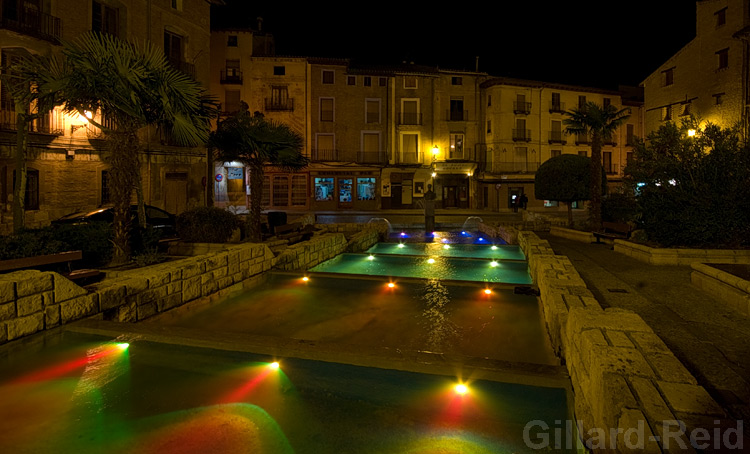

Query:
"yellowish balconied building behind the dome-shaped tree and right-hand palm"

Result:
[[477, 78, 642, 210]]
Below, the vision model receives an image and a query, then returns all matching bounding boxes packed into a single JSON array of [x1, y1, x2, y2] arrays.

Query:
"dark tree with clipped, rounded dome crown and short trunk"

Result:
[[534, 154, 606, 227]]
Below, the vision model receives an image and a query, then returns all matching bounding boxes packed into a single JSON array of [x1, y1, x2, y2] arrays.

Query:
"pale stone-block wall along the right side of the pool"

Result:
[[518, 232, 726, 453]]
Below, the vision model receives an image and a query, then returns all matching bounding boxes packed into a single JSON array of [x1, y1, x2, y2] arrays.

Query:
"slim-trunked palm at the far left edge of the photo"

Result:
[[0, 54, 61, 233]]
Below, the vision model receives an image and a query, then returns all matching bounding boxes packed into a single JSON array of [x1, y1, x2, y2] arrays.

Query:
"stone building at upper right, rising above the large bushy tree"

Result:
[[641, 0, 750, 134]]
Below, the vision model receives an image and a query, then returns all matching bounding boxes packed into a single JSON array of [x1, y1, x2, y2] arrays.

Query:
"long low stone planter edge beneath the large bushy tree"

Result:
[[614, 240, 750, 265]]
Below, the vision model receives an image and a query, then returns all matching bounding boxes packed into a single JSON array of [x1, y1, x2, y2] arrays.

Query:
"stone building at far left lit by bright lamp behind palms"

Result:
[[0, 0, 216, 233]]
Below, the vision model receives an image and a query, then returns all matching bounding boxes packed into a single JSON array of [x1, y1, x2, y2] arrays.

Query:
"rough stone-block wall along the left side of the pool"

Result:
[[0, 243, 276, 343]]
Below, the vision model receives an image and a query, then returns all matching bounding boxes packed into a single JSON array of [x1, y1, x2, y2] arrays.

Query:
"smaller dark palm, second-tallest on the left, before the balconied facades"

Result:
[[208, 102, 308, 242]]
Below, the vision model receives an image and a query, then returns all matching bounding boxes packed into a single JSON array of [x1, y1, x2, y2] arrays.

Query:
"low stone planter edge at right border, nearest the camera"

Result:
[[690, 263, 750, 316]]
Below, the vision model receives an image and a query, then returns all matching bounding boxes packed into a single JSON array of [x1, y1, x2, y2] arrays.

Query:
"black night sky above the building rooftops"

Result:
[[212, 0, 695, 89]]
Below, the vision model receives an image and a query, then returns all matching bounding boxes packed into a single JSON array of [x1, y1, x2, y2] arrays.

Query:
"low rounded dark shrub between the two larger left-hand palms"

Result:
[[177, 207, 242, 243]]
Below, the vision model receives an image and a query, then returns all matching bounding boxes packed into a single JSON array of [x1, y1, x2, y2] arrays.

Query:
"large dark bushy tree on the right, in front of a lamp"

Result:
[[625, 119, 750, 247]]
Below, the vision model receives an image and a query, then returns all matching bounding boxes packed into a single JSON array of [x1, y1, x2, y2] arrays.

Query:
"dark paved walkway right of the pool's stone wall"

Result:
[[539, 233, 750, 435]]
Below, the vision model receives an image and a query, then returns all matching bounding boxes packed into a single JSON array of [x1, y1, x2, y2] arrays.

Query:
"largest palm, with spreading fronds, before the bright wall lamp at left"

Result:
[[39, 32, 216, 264]]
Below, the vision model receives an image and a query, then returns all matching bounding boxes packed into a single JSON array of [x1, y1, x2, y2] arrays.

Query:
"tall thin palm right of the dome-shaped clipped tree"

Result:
[[563, 101, 630, 230]]
